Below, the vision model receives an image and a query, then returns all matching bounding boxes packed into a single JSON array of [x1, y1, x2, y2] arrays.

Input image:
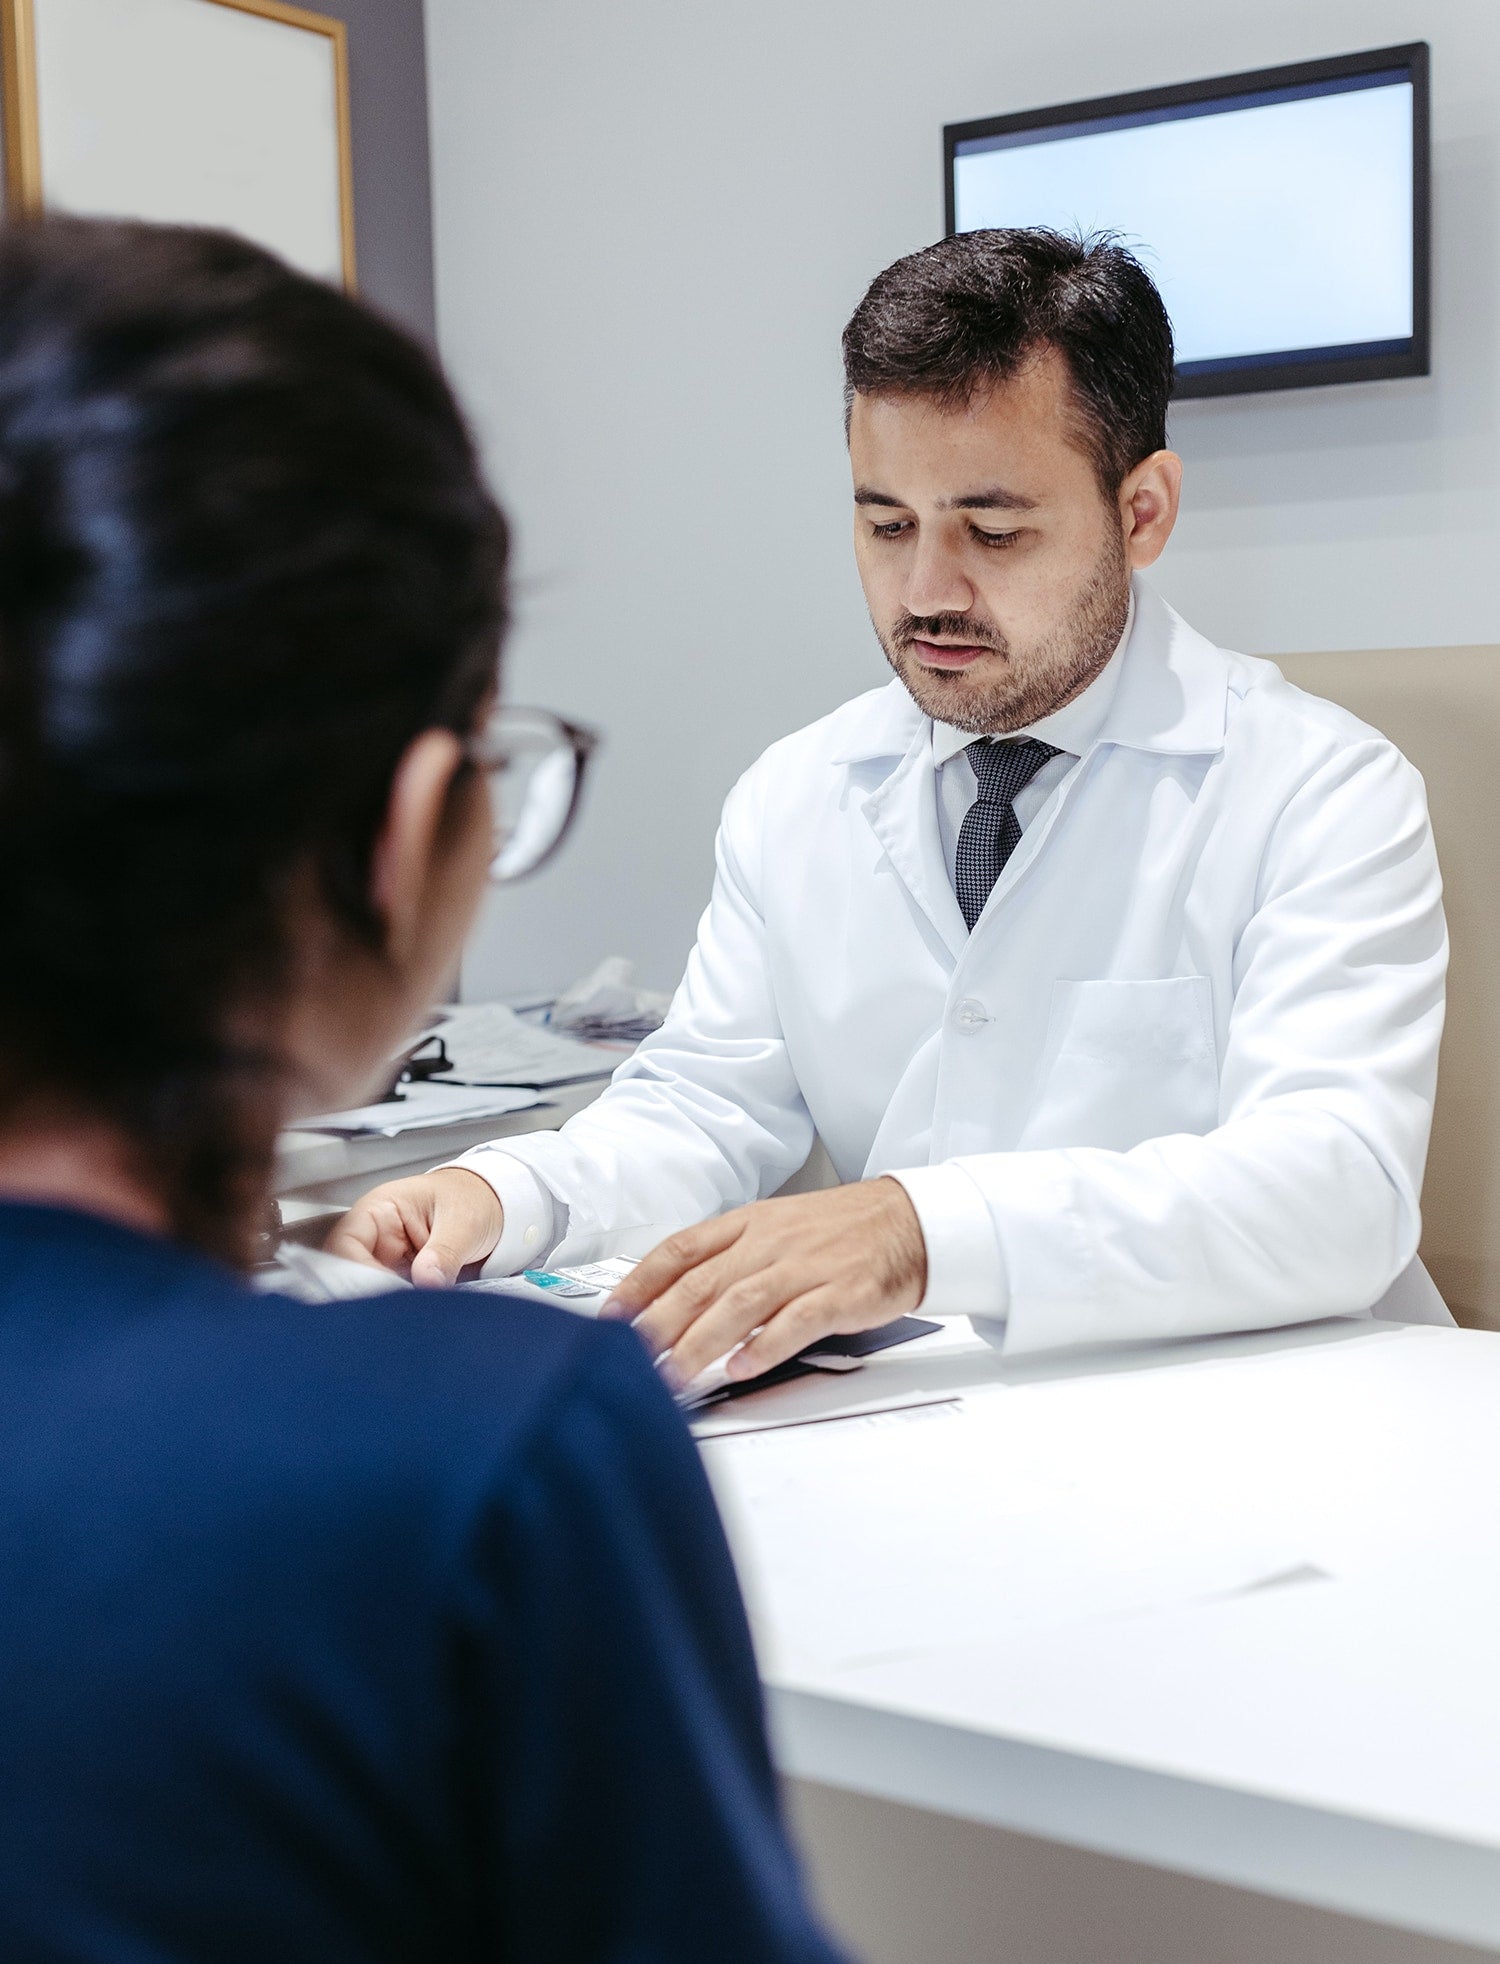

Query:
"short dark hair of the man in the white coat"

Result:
[[844, 226, 1172, 497]]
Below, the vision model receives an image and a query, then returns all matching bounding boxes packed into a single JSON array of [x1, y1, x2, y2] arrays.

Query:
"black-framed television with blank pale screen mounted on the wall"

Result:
[[942, 41, 1429, 397]]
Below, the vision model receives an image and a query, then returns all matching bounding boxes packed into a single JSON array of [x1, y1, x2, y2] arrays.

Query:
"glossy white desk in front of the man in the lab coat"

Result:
[[703, 1322, 1500, 1946]]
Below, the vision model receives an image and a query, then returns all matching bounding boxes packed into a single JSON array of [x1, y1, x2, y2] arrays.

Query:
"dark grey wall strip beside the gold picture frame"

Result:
[[0, 0, 434, 342]]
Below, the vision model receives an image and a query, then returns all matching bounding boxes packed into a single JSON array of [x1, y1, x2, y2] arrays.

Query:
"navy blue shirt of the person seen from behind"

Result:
[[0, 1206, 832, 1964]]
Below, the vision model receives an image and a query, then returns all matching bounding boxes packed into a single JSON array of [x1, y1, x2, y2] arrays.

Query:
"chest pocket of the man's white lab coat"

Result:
[[1021, 976, 1219, 1153]]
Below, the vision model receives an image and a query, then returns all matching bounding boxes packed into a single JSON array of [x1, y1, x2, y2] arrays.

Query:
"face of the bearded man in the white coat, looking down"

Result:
[[848, 350, 1180, 735]]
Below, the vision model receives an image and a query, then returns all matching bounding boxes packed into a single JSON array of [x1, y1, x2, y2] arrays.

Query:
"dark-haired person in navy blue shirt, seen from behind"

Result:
[[0, 222, 830, 1964]]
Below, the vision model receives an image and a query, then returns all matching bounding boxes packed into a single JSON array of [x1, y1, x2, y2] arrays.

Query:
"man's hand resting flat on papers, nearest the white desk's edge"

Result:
[[601, 1178, 927, 1385]]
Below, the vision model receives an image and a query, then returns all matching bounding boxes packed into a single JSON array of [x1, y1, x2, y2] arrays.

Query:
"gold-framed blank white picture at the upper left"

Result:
[[0, 0, 355, 291]]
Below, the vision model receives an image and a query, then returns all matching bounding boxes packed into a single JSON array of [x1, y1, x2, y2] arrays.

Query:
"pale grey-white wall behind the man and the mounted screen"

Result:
[[428, 0, 1500, 996]]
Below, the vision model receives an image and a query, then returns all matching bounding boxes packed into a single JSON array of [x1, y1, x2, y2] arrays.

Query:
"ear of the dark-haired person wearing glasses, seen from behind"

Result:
[[369, 729, 489, 966]]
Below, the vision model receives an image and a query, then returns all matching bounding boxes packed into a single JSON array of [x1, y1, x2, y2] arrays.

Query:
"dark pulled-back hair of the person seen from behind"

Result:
[[0, 220, 507, 1259]]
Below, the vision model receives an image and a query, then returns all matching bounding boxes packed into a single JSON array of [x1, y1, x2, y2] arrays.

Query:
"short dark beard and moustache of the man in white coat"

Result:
[[876, 526, 1131, 737]]
